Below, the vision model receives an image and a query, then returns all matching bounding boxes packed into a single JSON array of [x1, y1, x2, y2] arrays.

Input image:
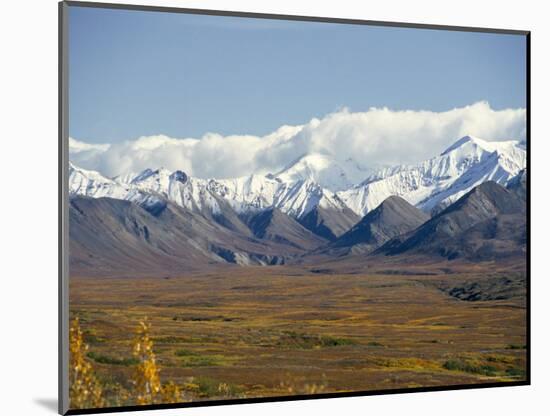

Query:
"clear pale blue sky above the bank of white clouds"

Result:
[[69, 7, 526, 143]]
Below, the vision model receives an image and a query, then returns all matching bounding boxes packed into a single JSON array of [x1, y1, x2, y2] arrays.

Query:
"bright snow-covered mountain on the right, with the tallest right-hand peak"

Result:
[[337, 136, 527, 216]]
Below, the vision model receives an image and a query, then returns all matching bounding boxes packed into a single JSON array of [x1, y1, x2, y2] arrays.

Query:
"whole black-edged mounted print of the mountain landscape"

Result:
[[59, 1, 530, 414]]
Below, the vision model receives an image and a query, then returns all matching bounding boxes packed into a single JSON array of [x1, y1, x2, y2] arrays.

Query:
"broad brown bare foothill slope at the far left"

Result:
[[69, 197, 303, 277]]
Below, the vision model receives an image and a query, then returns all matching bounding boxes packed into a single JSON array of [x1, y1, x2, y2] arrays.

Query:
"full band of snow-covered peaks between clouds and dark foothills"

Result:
[[69, 136, 526, 219]]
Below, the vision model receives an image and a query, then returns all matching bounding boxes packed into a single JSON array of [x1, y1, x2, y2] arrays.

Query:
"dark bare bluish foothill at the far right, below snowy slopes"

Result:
[[377, 181, 527, 260]]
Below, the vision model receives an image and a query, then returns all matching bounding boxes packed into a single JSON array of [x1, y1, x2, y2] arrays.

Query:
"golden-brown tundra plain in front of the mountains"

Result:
[[70, 264, 526, 408]]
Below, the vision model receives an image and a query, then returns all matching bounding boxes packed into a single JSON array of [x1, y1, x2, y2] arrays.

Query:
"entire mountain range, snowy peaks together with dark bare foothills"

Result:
[[69, 136, 527, 275]]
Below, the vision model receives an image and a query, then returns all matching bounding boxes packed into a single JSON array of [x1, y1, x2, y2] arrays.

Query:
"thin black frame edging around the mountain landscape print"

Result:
[[58, 1, 531, 415]]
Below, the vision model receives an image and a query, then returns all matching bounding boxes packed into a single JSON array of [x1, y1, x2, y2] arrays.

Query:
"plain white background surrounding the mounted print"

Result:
[[0, 0, 550, 416]]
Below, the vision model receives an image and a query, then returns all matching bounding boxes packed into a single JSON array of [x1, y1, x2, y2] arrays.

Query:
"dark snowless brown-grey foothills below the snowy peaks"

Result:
[[69, 174, 527, 276]]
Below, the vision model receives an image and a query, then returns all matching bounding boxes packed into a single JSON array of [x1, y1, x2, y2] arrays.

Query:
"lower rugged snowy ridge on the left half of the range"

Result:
[[69, 164, 345, 218]]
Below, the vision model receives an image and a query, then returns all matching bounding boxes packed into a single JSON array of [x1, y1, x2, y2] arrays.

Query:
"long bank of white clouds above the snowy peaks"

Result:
[[69, 102, 526, 178]]
